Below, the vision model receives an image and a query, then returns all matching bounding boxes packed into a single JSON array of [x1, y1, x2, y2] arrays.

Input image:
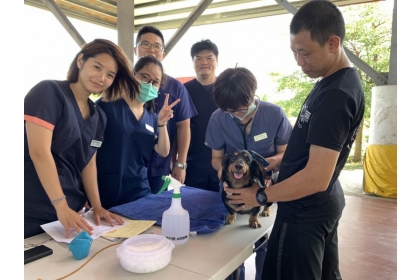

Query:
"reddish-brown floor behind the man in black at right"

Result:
[[241, 170, 397, 280]]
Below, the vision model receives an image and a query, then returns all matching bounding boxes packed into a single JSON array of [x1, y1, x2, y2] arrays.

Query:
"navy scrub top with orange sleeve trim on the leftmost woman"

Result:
[[24, 80, 106, 221]]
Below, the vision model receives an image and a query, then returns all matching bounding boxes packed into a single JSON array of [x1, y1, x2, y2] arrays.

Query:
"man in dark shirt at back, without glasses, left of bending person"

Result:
[[184, 40, 220, 192]]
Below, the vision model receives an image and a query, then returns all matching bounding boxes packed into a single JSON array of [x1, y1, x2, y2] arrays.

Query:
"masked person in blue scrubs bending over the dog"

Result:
[[205, 67, 292, 279]]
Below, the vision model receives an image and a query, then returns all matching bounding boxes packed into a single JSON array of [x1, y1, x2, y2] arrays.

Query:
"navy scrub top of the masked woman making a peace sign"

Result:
[[96, 99, 158, 209]]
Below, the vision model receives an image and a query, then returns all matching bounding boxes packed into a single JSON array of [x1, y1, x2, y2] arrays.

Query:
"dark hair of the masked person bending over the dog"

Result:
[[213, 67, 257, 111]]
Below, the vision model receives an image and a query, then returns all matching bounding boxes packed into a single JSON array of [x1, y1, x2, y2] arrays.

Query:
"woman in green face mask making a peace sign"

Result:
[[96, 56, 180, 209]]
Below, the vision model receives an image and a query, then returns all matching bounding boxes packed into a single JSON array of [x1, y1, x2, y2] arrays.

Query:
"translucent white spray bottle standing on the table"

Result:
[[162, 176, 190, 245]]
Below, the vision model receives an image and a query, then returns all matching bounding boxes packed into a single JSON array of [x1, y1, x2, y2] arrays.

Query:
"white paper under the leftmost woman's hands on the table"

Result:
[[41, 212, 127, 243]]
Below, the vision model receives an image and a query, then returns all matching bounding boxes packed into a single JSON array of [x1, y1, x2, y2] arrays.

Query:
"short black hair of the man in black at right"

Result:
[[290, 0, 346, 46]]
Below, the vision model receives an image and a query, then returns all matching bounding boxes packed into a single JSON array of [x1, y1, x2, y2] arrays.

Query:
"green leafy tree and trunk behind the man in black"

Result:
[[270, 2, 392, 162]]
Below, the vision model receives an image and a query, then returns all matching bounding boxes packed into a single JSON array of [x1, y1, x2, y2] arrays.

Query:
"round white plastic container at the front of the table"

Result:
[[117, 234, 175, 273]]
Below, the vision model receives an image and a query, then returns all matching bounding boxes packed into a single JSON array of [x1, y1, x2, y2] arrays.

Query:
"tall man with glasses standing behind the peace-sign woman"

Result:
[[134, 26, 197, 193]]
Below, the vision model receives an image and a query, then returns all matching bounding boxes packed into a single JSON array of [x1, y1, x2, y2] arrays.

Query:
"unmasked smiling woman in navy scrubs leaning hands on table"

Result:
[[24, 39, 139, 238]]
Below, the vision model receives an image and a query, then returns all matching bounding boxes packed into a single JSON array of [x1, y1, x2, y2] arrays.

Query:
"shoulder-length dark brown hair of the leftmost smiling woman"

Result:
[[67, 39, 140, 99]]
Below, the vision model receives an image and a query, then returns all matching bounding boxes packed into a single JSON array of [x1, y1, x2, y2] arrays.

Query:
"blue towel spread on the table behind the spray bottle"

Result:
[[109, 186, 227, 234]]
